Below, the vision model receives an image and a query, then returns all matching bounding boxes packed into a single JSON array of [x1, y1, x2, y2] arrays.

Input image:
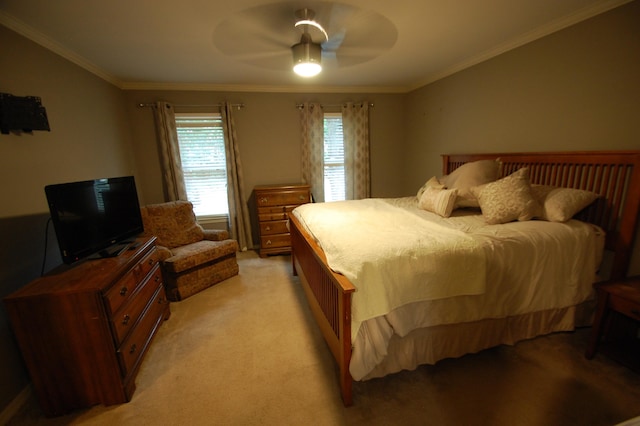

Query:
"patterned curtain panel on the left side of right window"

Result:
[[300, 102, 324, 202]]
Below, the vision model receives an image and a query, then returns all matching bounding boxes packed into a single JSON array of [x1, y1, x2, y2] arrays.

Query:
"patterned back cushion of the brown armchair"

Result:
[[140, 201, 204, 249]]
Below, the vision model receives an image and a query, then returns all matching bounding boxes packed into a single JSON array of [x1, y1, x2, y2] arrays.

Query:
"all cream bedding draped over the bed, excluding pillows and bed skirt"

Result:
[[294, 197, 604, 380]]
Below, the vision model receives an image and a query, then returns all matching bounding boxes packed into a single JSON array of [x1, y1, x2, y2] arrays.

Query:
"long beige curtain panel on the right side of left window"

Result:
[[220, 102, 253, 251]]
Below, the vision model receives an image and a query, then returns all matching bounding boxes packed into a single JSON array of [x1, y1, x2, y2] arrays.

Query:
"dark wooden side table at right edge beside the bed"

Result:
[[585, 276, 640, 372]]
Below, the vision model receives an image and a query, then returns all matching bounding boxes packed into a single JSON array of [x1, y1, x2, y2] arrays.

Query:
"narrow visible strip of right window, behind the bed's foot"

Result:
[[324, 112, 346, 201]]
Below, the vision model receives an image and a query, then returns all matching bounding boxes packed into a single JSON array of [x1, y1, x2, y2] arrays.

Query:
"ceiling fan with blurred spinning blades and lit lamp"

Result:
[[213, 1, 398, 77]]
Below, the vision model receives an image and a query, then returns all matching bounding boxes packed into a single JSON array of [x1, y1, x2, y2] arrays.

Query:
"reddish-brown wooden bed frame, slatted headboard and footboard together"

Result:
[[291, 151, 640, 406]]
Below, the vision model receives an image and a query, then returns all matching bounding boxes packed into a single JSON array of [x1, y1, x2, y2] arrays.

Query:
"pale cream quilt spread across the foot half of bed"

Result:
[[295, 199, 486, 337]]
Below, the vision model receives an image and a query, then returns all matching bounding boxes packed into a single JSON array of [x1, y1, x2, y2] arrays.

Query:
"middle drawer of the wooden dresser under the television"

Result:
[[111, 265, 162, 346]]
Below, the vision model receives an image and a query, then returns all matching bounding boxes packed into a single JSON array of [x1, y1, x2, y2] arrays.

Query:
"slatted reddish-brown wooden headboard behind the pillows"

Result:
[[442, 151, 640, 278]]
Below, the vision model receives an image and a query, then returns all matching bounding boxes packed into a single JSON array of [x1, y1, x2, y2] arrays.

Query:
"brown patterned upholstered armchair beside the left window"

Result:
[[140, 201, 238, 301]]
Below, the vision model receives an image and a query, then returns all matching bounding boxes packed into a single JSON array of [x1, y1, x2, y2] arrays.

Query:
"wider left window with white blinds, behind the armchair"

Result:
[[176, 113, 229, 218]]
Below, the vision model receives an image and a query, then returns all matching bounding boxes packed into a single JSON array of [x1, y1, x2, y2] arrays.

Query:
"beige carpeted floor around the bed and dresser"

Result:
[[10, 252, 640, 426]]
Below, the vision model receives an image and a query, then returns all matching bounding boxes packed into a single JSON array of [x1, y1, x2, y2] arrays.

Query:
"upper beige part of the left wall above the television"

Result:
[[0, 26, 135, 217]]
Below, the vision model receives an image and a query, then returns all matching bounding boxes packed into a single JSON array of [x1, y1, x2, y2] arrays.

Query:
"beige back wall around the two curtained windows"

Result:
[[126, 91, 404, 204]]
